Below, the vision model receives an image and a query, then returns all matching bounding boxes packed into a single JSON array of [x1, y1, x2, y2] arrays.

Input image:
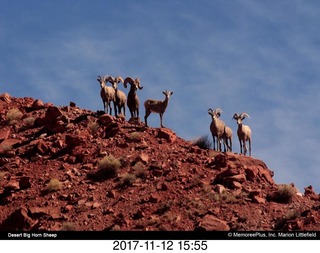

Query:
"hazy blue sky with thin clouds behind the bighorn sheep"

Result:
[[0, 0, 320, 193]]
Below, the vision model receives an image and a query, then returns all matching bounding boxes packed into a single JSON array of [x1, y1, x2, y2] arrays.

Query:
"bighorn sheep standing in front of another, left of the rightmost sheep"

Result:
[[208, 108, 225, 151]]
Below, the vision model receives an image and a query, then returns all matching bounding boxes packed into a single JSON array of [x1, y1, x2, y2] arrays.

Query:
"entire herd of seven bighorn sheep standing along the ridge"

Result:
[[97, 75, 251, 156]]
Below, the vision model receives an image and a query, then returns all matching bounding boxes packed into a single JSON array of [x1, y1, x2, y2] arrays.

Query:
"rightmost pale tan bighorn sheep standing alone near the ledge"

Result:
[[233, 112, 251, 156]]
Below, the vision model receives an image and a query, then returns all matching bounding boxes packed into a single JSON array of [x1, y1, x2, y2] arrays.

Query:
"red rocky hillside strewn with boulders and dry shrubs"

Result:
[[0, 93, 320, 231]]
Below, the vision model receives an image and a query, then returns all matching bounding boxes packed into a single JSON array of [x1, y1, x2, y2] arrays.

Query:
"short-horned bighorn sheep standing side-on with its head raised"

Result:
[[144, 90, 173, 127]]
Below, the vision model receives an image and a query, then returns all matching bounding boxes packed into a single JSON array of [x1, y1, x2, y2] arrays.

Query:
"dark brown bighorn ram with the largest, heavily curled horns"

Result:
[[123, 77, 143, 118]]
